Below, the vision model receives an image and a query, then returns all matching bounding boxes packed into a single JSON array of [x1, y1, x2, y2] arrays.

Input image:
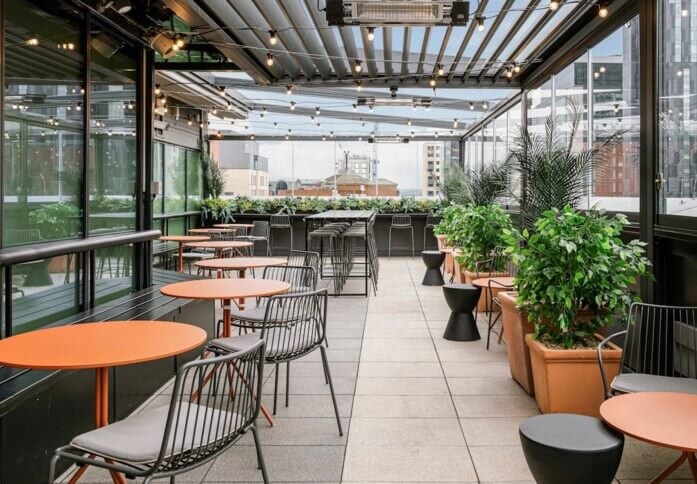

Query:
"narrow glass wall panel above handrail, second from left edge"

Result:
[[89, 26, 138, 235]]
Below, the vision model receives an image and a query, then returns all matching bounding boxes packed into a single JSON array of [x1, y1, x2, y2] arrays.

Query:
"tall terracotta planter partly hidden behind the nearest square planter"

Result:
[[499, 292, 535, 395]]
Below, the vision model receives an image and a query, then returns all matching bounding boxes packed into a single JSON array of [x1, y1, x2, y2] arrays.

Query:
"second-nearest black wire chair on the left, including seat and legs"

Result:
[[208, 289, 343, 435]]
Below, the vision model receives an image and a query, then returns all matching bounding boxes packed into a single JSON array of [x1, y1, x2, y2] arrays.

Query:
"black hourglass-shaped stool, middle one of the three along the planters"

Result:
[[443, 284, 482, 341]]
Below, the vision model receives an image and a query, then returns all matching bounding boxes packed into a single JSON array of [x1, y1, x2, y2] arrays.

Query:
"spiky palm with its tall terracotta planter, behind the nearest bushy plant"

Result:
[[498, 103, 617, 395]]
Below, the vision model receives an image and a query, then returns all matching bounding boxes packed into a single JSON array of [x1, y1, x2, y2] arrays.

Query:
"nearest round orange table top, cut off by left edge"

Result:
[[0, 321, 208, 370]]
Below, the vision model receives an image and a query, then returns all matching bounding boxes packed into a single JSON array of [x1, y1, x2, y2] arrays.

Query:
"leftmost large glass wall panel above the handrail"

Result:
[[2, 0, 84, 246]]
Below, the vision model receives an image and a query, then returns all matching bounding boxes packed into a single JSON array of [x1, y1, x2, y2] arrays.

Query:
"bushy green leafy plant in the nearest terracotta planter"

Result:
[[504, 206, 650, 348]]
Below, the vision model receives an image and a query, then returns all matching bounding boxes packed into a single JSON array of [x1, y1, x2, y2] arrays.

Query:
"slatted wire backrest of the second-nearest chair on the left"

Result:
[[260, 289, 327, 362]]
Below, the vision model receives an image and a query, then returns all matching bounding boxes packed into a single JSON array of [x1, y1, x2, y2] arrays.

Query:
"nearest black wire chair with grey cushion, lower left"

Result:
[[48, 341, 269, 483]]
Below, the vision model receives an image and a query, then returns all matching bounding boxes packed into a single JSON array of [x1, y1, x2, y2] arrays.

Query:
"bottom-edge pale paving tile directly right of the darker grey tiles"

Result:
[[344, 445, 477, 482]]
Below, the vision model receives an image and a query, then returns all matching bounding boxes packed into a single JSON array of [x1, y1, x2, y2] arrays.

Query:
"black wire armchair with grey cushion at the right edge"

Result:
[[598, 303, 697, 398]]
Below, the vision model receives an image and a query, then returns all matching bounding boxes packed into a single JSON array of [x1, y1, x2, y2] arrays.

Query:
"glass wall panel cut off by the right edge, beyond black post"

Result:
[[657, 0, 697, 217]]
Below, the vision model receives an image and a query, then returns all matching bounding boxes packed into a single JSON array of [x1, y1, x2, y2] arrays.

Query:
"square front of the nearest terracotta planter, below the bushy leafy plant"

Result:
[[525, 335, 622, 417]]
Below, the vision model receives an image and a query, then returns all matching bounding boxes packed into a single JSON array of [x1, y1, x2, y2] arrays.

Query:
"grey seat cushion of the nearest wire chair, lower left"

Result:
[[71, 403, 239, 465]]
